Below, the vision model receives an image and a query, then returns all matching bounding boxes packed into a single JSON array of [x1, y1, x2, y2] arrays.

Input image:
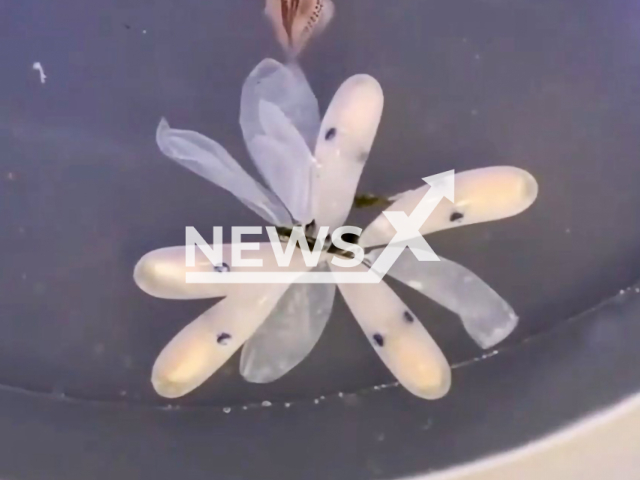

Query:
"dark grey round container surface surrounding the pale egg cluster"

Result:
[[0, 0, 640, 480]]
